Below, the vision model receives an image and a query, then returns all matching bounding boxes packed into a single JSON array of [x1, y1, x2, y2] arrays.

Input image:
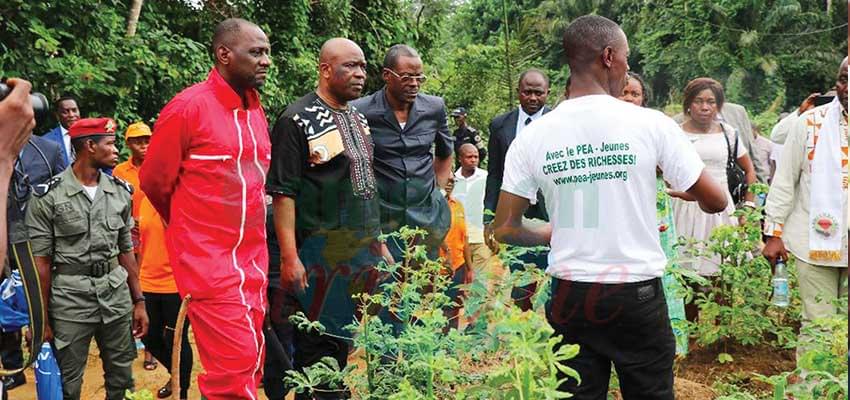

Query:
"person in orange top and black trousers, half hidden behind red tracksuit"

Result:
[[134, 197, 193, 399]]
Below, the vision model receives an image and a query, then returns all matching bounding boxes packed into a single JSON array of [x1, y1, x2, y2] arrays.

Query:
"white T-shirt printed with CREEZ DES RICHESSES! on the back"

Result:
[[502, 95, 704, 283]]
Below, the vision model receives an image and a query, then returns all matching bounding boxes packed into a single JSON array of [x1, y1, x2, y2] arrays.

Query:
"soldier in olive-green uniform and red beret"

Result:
[[26, 118, 148, 400]]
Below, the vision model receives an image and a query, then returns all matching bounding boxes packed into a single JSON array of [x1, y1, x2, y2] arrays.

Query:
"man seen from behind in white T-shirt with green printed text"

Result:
[[494, 15, 726, 400]]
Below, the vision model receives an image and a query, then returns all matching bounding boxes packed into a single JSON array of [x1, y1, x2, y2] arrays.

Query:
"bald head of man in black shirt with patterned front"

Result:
[[319, 38, 366, 106]]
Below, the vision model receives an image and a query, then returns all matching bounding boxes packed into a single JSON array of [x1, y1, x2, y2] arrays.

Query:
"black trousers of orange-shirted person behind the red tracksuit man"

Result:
[[142, 292, 193, 399]]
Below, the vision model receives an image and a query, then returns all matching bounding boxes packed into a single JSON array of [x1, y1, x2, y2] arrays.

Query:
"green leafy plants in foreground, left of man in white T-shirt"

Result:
[[286, 227, 579, 400]]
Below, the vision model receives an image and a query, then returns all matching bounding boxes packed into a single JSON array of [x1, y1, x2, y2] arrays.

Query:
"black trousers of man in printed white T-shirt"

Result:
[[546, 278, 676, 400]]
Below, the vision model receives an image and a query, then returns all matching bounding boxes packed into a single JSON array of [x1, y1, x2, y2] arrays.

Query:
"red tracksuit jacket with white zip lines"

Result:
[[139, 68, 271, 309]]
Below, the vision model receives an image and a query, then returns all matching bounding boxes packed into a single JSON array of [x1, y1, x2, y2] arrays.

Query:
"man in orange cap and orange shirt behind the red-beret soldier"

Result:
[[112, 122, 151, 253]]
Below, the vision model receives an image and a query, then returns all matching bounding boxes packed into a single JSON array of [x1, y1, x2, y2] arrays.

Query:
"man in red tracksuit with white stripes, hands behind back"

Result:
[[140, 18, 271, 400]]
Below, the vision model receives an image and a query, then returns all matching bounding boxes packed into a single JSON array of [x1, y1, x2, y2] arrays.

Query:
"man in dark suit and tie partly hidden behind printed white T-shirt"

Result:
[[484, 69, 549, 310]]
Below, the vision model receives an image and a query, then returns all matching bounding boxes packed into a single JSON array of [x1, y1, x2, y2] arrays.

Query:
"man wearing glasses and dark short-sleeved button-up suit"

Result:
[[352, 44, 454, 261]]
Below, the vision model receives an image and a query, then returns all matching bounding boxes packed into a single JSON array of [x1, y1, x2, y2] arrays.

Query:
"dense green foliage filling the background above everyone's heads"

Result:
[[0, 0, 847, 142]]
